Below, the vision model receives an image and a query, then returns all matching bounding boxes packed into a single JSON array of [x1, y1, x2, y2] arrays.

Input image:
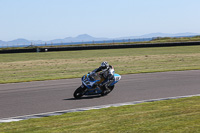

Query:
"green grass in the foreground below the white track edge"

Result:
[[0, 97, 200, 133]]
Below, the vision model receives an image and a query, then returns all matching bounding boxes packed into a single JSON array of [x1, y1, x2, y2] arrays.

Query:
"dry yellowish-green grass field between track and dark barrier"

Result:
[[0, 46, 200, 83]]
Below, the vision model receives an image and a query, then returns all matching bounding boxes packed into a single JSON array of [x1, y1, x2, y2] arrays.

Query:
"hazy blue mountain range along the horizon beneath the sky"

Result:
[[0, 32, 200, 46]]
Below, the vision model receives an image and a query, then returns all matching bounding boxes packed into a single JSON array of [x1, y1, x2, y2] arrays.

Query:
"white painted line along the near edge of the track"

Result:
[[0, 94, 200, 123]]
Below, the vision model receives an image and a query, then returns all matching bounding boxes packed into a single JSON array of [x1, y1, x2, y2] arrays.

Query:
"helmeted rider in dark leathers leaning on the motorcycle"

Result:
[[92, 61, 114, 94]]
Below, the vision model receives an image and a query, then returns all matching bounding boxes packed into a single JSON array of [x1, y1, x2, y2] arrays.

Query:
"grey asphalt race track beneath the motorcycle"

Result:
[[0, 70, 200, 119]]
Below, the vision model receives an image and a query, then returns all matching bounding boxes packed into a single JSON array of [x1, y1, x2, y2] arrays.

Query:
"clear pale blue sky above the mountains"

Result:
[[0, 0, 200, 41]]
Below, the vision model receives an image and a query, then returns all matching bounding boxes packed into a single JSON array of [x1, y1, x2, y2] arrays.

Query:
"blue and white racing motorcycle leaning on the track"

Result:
[[74, 69, 121, 99]]
